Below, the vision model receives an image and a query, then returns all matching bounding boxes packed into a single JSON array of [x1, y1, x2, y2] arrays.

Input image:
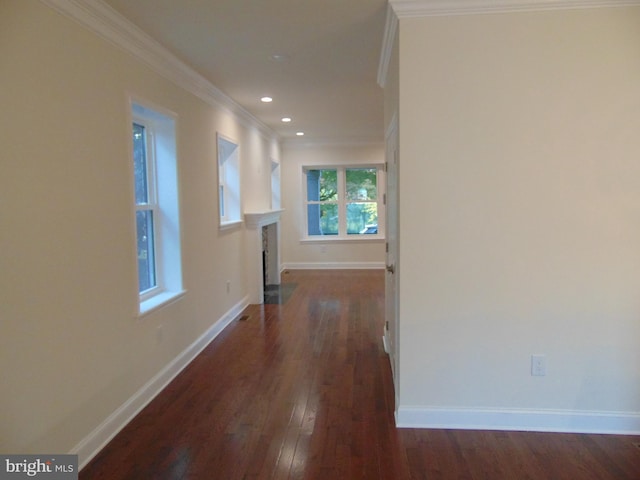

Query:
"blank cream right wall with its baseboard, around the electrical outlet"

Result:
[[399, 4, 640, 431]]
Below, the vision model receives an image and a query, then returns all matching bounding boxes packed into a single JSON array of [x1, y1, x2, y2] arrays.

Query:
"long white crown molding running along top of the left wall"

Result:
[[40, 0, 279, 139]]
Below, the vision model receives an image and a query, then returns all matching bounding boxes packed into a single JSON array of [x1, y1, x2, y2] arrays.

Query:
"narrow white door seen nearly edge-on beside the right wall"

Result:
[[384, 121, 400, 404]]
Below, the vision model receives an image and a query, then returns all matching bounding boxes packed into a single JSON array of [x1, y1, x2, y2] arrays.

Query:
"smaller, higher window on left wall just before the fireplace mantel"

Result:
[[218, 134, 242, 226]]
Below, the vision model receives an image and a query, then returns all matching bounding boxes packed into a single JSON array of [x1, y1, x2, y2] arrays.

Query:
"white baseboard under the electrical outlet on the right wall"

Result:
[[396, 407, 640, 435]]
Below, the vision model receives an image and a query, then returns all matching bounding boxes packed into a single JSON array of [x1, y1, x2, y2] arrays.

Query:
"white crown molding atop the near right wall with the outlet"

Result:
[[389, 0, 640, 18]]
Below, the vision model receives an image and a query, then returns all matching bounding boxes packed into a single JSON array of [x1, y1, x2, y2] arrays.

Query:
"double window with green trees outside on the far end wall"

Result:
[[304, 165, 384, 239]]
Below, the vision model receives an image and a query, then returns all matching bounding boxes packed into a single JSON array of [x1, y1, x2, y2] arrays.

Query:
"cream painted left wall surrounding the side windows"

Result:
[[0, 0, 279, 462]]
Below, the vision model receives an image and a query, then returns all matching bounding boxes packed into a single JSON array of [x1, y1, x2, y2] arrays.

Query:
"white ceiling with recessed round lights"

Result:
[[104, 0, 387, 143]]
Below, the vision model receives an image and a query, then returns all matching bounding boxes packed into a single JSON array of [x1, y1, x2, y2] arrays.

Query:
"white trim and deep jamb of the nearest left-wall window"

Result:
[[128, 98, 186, 318]]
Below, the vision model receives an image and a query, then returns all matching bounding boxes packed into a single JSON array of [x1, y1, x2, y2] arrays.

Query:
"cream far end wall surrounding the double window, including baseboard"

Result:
[[280, 144, 385, 268]]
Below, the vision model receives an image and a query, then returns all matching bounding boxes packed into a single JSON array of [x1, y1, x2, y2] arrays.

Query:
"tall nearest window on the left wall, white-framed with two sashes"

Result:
[[131, 104, 182, 313]]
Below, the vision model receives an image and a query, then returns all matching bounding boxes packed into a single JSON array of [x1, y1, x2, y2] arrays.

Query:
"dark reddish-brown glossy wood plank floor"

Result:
[[80, 271, 640, 480]]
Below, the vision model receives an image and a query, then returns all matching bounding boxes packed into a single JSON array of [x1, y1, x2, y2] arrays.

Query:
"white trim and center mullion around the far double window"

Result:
[[300, 163, 386, 244]]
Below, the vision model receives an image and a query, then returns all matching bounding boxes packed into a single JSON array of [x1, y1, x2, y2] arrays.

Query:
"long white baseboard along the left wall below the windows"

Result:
[[69, 296, 249, 469]]
